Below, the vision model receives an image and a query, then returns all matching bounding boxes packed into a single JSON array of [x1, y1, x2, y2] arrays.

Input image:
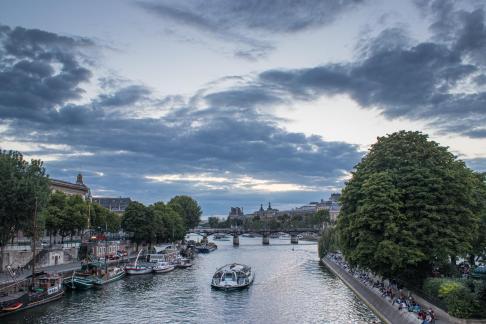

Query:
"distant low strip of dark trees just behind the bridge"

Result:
[[208, 210, 331, 230]]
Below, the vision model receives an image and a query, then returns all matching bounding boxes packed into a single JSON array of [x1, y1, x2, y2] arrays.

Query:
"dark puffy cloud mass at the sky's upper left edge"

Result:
[[0, 26, 92, 120]]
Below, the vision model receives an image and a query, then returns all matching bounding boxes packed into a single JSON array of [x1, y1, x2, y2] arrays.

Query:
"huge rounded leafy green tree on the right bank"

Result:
[[337, 131, 479, 279]]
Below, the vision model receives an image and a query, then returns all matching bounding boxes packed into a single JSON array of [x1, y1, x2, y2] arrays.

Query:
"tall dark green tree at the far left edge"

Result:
[[0, 151, 49, 268]]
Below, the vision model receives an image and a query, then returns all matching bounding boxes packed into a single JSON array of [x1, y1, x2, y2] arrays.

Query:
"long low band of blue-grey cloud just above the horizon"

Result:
[[5, 108, 362, 213]]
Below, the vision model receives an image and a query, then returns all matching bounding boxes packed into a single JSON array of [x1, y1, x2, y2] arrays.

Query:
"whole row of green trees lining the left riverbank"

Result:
[[0, 150, 201, 268]]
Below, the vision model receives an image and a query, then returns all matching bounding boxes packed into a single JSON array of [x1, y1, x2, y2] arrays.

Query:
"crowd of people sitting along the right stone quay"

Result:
[[326, 253, 436, 324]]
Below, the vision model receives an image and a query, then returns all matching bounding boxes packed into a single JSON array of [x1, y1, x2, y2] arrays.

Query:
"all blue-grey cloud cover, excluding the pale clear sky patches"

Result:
[[0, 1, 486, 215]]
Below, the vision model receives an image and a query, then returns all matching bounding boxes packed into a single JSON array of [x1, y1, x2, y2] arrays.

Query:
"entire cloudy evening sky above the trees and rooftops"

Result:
[[0, 0, 486, 216]]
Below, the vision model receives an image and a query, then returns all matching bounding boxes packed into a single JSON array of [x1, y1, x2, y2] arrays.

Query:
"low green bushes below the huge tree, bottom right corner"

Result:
[[423, 278, 481, 318]]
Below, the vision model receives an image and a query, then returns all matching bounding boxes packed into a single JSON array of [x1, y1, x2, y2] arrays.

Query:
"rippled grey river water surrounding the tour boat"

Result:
[[5, 237, 379, 324]]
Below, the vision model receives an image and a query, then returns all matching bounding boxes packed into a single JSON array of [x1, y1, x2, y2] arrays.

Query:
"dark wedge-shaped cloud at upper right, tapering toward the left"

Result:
[[257, 2, 486, 138]]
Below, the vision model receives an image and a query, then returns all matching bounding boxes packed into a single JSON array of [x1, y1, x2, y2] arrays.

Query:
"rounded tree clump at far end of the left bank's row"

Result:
[[121, 196, 202, 249]]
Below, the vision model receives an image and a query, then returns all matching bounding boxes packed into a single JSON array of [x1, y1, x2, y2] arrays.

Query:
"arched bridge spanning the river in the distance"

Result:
[[188, 227, 320, 245]]
